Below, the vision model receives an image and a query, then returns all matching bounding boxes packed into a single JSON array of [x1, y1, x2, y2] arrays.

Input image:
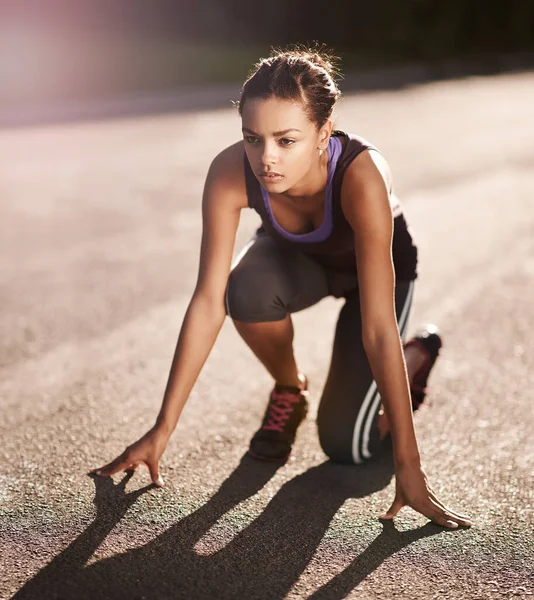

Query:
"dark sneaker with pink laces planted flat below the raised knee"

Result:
[[248, 377, 308, 462]]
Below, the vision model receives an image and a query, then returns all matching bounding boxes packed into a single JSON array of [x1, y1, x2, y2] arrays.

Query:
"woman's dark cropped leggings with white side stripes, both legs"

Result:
[[226, 234, 414, 463]]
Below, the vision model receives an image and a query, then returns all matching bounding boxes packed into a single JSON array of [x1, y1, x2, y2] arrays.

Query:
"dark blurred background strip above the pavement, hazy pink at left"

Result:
[[0, 0, 534, 105]]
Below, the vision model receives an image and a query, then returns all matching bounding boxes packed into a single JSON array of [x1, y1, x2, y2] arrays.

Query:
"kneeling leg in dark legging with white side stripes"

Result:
[[317, 281, 414, 463]]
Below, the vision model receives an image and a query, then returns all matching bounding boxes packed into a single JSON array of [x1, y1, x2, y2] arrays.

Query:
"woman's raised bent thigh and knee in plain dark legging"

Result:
[[226, 233, 329, 323]]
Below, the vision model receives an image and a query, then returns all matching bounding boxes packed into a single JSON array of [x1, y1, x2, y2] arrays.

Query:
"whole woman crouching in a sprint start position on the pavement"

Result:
[[93, 49, 470, 527]]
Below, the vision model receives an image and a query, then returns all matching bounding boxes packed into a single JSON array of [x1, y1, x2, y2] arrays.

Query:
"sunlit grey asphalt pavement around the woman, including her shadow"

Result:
[[0, 72, 534, 600]]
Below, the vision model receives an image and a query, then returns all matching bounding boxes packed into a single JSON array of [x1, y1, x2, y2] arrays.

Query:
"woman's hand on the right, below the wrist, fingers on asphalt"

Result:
[[379, 461, 471, 529]]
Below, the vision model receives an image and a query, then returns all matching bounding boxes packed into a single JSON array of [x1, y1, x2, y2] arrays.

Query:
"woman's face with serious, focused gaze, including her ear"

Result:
[[241, 98, 331, 193]]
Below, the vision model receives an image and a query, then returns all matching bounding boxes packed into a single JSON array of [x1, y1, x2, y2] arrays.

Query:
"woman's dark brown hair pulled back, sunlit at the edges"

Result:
[[235, 45, 341, 129]]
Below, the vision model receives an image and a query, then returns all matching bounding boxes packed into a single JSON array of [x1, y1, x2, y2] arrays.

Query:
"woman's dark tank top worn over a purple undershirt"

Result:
[[244, 130, 417, 280]]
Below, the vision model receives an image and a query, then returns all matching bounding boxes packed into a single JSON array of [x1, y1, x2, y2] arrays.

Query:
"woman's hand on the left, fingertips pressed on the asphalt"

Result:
[[89, 429, 168, 487]]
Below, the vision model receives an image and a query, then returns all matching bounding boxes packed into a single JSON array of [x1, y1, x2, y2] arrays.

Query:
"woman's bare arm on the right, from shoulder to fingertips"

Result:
[[341, 151, 471, 527]]
